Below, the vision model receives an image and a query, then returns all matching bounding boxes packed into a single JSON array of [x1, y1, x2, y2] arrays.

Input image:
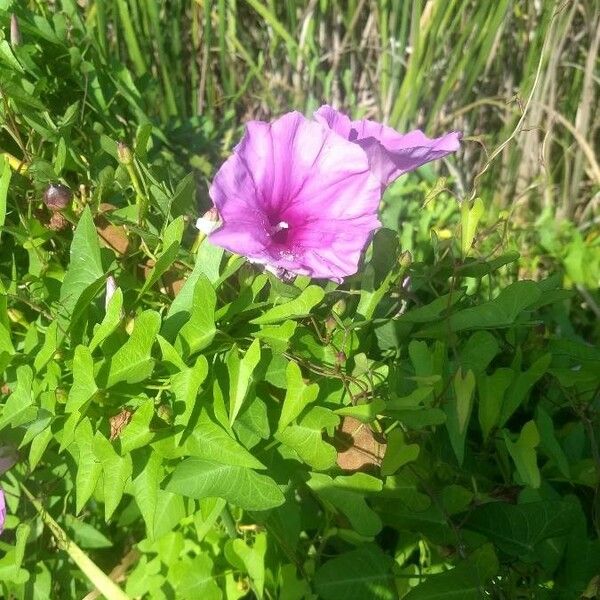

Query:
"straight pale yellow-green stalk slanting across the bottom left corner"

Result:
[[20, 483, 130, 600]]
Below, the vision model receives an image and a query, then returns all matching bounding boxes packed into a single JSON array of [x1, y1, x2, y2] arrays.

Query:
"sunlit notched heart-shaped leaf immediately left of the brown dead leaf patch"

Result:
[[275, 406, 339, 471]]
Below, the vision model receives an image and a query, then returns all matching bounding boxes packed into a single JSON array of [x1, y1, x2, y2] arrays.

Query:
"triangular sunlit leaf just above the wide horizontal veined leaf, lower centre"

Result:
[[184, 410, 266, 469]]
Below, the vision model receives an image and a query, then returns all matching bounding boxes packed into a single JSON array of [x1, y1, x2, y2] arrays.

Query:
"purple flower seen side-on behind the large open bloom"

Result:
[[315, 106, 462, 187]]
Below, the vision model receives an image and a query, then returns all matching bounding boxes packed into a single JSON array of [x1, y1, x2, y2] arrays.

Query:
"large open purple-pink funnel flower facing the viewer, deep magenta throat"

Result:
[[210, 112, 381, 281]]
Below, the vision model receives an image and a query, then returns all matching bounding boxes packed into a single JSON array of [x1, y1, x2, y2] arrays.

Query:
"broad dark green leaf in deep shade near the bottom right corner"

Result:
[[466, 500, 577, 560]]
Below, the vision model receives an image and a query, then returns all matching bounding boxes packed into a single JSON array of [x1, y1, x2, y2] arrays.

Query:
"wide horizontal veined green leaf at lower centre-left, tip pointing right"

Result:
[[166, 458, 285, 510]]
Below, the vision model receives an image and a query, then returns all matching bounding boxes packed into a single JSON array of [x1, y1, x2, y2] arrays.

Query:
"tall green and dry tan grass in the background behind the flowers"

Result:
[[16, 0, 600, 222]]
